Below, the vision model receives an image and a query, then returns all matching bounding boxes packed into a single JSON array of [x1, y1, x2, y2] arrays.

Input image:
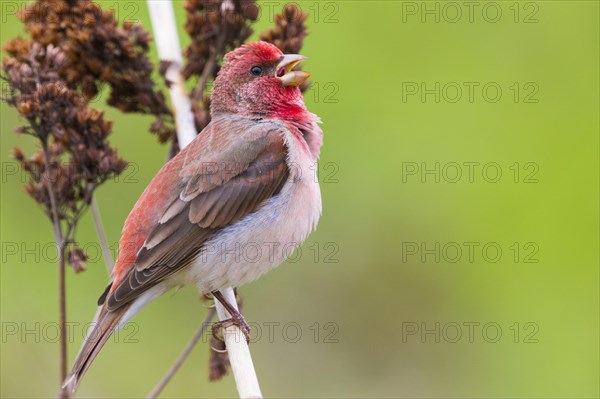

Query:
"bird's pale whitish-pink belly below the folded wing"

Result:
[[170, 155, 321, 293]]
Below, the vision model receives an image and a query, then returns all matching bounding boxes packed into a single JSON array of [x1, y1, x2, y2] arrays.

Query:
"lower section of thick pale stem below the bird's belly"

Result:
[[215, 288, 262, 398]]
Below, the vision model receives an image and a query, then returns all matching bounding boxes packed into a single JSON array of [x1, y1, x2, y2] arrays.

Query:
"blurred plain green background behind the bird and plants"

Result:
[[0, 1, 599, 398]]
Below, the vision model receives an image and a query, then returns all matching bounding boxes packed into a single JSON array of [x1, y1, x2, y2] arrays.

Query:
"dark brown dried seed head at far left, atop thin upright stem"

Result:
[[2, 39, 126, 228]]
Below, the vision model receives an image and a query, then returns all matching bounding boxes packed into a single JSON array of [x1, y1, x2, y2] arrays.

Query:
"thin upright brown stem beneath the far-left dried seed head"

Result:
[[42, 140, 69, 399]]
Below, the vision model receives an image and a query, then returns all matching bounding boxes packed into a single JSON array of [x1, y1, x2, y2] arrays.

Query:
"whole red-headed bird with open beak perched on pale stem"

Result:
[[64, 42, 323, 392]]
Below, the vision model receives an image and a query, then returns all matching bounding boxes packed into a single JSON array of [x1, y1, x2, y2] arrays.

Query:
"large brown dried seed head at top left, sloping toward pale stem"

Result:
[[12, 0, 175, 142]]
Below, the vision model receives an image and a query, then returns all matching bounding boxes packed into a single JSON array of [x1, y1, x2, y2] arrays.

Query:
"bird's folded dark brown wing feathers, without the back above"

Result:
[[106, 131, 289, 310]]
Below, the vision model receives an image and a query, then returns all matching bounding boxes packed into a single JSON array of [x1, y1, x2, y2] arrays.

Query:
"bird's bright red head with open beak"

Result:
[[211, 42, 310, 119]]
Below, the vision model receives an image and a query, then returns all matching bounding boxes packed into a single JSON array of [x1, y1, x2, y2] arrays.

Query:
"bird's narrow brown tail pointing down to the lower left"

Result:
[[63, 305, 129, 393]]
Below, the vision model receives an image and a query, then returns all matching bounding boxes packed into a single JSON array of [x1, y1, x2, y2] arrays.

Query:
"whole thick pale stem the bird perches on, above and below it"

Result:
[[147, 0, 262, 398]]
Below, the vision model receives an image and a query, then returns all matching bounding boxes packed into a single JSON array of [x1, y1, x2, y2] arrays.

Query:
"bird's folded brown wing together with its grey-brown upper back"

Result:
[[106, 123, 289, 309]]
